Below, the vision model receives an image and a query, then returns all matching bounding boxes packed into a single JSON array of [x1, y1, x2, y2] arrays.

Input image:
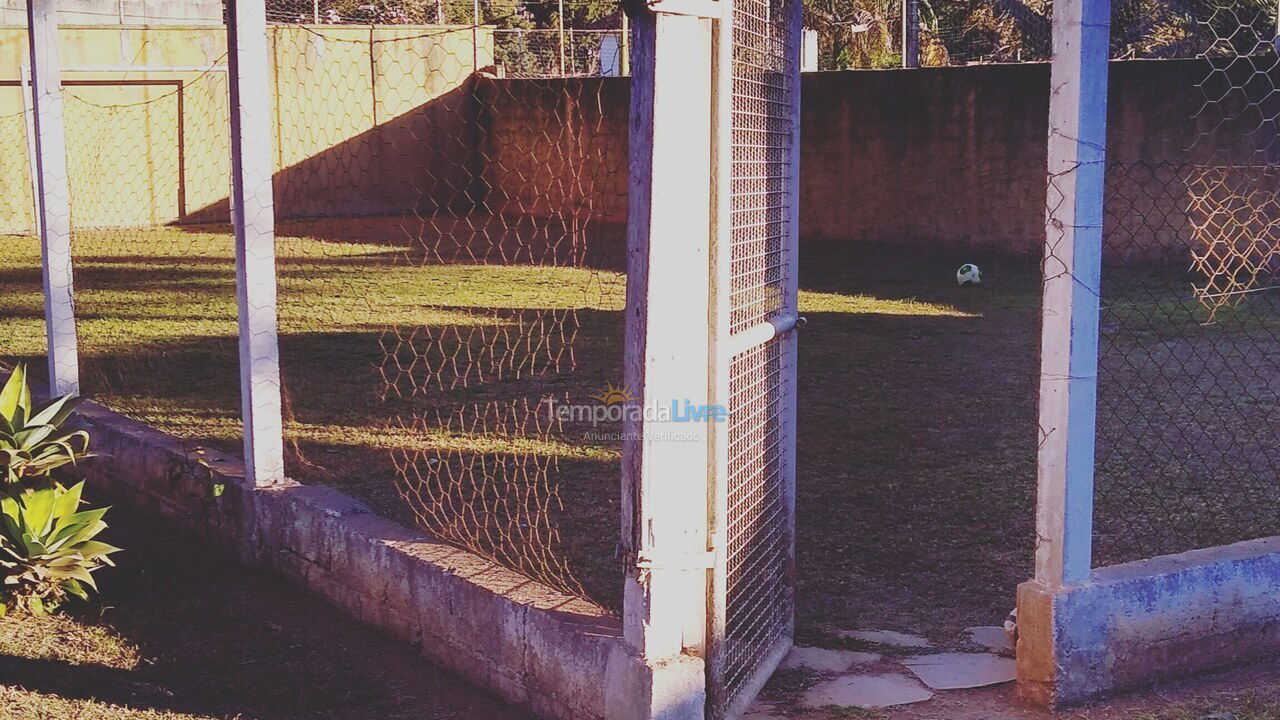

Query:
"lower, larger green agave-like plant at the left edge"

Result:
[[0, 483, 120, 614]]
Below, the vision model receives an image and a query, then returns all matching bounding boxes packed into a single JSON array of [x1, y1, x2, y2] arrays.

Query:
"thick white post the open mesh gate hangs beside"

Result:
[[614, 3, 718, 720]]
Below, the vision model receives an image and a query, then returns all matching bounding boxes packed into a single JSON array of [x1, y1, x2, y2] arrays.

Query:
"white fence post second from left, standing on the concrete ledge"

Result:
[[227, 0, 284, 486]]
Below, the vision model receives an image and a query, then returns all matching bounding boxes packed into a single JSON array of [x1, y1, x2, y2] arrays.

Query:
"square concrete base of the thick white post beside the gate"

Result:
[[605, 646, 707, 720]]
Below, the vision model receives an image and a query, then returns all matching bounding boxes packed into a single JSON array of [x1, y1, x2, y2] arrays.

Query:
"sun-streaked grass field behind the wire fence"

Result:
[[0, 223, 1268, 644]]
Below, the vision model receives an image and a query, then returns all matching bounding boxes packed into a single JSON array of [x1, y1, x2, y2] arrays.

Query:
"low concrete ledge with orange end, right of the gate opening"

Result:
[[1018, 538, 1280, 707]]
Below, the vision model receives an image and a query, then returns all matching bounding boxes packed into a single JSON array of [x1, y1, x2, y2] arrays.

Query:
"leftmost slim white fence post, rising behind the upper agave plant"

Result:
[[27, 0, 79, 395]]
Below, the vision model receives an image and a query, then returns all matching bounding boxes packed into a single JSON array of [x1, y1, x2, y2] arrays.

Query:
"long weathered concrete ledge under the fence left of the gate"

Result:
[[77, 404, 629, 720]]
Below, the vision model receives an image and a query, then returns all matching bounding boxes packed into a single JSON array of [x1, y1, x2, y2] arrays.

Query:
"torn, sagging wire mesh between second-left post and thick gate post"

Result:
[[273, 26, 626, 606]]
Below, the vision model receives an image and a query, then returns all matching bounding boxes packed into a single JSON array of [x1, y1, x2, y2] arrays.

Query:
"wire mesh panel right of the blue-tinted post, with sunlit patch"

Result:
[[1094, 1, 1280, 565]]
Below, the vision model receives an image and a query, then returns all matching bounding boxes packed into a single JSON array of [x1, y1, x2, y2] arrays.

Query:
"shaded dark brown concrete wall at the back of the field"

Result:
[[486, 60, 1235, 256]]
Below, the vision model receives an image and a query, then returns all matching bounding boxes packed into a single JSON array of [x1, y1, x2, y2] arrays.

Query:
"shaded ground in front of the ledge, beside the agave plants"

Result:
[[0, 499, 530, 720]]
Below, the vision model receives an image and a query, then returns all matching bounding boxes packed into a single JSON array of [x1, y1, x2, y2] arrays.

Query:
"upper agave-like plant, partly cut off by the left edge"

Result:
[[0, 365, 90, 487]]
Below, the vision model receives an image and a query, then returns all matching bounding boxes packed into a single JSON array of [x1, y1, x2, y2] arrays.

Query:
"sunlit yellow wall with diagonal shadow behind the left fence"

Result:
[[0, 26, 493, 232]]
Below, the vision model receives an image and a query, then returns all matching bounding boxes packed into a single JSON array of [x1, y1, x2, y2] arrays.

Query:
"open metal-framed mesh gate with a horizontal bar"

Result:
[[707, 0, 801, 720]]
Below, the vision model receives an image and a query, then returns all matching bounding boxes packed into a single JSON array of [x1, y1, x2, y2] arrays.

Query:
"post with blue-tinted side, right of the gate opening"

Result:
[[1036, 0, 1111, 587]]
